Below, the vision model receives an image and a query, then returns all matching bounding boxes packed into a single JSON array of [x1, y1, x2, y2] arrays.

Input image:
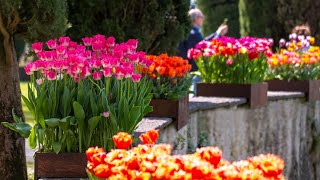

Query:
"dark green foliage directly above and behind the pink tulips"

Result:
[[67, 0, 190, 54]]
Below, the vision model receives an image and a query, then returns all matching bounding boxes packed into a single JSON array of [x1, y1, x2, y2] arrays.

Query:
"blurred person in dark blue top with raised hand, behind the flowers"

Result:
[[177, 9, 228, 93]]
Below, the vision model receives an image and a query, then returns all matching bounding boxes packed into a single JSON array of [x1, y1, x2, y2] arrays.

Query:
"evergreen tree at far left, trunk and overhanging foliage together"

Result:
[[0, 0, 67, 180]]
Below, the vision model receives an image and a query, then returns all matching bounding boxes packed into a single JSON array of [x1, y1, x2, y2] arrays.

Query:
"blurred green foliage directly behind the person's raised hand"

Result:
[[197, 0, 239, 37]]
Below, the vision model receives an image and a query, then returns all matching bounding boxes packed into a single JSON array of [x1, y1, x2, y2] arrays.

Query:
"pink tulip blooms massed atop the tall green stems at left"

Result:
[[25, 34, 152, 83]]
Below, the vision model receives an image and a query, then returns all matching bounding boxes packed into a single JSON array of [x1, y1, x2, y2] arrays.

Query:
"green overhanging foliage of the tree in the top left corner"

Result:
[[0, 0, 67, 42]]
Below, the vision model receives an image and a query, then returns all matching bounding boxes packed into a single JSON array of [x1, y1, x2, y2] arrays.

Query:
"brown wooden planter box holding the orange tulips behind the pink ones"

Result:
[[146, 95, 189, 130]]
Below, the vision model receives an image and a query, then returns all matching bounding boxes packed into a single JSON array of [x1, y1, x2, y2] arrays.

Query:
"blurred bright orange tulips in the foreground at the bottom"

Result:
[[86, 130, 285, 180]]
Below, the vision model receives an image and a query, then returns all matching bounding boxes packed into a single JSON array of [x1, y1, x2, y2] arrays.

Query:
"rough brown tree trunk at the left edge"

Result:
[[0, 34, 27, 180]]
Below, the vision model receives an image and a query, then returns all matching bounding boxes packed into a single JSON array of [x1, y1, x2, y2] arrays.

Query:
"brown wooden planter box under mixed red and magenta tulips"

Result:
[[197, 83, 268, 108]]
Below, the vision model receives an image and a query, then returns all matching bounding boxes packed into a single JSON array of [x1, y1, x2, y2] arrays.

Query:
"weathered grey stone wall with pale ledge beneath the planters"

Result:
[[159, 93, 320, 180]]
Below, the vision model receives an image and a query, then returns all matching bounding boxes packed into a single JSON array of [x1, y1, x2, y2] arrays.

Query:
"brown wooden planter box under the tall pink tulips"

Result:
[[34, 152, 88, 180]]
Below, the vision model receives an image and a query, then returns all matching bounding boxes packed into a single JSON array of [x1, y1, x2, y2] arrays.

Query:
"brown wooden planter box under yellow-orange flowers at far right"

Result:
[[268, 80, 320, 101]]
